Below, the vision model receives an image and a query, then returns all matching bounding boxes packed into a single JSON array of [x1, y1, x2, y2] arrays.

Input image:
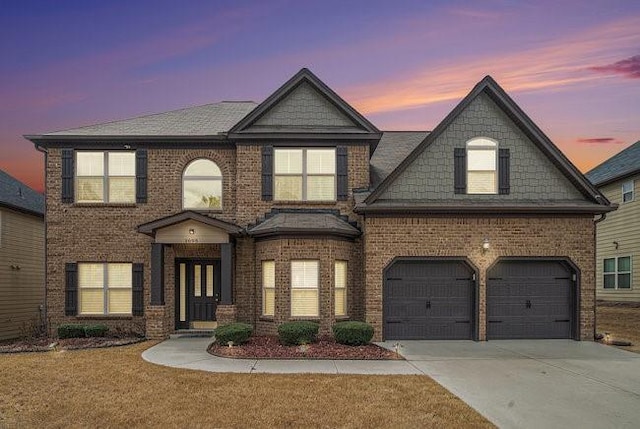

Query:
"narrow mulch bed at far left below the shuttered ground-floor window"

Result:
[[0, 337, 145, 353]]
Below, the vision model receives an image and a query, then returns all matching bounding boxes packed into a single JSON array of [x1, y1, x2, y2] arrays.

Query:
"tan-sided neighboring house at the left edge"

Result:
[[0, 170, 45, 340]]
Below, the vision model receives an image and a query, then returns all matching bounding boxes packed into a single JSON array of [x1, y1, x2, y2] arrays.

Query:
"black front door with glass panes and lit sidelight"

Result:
[[176, 259, 220, 329]]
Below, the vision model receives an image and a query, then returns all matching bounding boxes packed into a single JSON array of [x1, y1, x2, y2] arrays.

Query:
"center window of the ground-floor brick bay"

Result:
[[291, 260, 320, 317]]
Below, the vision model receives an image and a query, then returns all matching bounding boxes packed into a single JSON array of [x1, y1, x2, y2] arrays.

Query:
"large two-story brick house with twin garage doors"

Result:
[[26, 69, 612, 340]]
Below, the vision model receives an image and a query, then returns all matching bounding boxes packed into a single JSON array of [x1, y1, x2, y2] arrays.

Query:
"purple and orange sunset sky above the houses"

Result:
[[0, 0, 640, 190]]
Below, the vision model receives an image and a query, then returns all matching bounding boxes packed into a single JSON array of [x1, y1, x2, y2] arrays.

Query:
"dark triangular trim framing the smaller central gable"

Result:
[[229, 68, 380, 139]]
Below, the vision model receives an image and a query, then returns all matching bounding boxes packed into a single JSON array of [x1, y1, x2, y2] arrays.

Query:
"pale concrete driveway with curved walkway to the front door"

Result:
[[142, 338, 640, 429]]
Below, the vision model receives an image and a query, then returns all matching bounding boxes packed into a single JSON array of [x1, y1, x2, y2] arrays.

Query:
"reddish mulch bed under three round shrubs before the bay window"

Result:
[[208, 337, 403, 360]]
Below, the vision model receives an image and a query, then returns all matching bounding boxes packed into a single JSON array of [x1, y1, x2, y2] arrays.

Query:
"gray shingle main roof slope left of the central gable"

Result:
[[37, 101, 257, 137]]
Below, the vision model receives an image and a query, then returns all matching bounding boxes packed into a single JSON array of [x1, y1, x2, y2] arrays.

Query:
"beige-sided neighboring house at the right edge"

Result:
[[586, 141, 640, 302]]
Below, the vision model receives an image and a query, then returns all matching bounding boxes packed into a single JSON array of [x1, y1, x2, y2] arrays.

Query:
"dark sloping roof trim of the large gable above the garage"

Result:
[[364, 76, 610, 207]]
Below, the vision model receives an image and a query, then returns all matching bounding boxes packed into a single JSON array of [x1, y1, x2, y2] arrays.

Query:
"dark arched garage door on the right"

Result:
[[487, 260, 574, 340]]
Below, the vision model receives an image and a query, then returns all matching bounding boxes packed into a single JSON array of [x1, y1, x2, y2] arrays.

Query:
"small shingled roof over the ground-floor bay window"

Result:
[[247, 212, 360, 237]]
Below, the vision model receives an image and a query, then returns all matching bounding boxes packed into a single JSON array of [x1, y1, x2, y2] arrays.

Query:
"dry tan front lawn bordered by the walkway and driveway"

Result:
[[0, 342, 491, 428]]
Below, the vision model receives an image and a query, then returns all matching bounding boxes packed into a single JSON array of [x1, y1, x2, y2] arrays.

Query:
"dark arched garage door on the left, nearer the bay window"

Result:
[[384, 260, 474, 340]]
